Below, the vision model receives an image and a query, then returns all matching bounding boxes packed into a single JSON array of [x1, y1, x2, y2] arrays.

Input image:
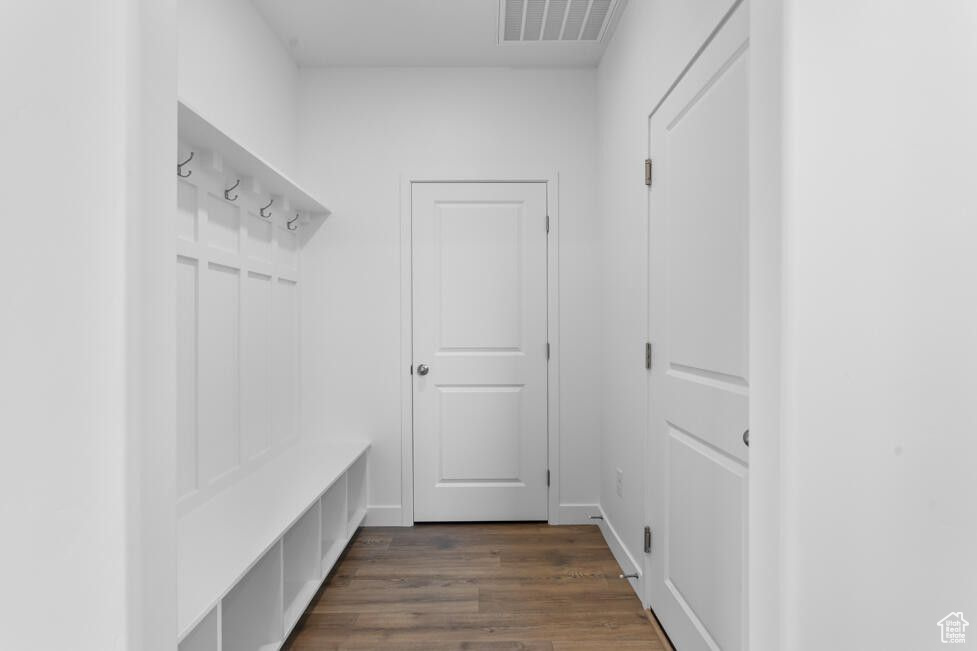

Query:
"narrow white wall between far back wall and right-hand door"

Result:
[[597, 0, 732, 595]]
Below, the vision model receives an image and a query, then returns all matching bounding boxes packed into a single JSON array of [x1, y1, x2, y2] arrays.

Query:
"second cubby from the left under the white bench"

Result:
[[221, 542, 283, 651]]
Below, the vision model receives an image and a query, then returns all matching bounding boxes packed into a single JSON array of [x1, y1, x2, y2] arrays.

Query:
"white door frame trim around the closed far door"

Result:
[[396, 170, 560, 527]]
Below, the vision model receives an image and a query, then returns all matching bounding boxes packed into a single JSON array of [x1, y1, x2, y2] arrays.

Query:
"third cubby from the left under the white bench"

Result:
[[284, 502, 322, 630]]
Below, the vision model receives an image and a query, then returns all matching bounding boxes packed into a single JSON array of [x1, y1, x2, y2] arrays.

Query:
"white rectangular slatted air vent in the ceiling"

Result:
[[499, 0, 619, 43]]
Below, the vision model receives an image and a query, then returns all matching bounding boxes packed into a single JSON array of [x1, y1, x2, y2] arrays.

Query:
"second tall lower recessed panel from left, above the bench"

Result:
[[198, 263, 241, 485]]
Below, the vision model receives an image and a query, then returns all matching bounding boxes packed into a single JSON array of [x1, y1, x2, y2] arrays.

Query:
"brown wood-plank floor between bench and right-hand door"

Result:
[[285, 524, 668, 651]]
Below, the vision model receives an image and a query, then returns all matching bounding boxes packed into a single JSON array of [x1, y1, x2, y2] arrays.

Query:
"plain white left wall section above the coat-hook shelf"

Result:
[[178, 0, 299, 176]]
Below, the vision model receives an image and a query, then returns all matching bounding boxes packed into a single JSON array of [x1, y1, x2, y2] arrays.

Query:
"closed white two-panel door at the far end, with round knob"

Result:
[[411, 183, 547, 521]]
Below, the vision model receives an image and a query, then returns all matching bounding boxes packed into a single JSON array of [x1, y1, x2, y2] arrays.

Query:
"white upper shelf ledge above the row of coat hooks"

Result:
[[177, 101, 330, 242]]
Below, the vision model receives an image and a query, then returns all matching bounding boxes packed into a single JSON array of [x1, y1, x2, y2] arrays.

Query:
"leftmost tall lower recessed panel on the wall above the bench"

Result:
[[176, 256, 198, 498]]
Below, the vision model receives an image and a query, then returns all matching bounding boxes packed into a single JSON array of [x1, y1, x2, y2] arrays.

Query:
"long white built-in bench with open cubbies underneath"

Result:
[[177, 439, 369, 651]]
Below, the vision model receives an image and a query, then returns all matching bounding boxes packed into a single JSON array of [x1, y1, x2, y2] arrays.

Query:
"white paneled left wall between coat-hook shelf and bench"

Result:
[[175, 148, 299, 510]]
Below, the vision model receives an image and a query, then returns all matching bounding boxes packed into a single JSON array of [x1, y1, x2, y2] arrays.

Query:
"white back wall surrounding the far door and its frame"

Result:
[[299, 68, 600, 523]]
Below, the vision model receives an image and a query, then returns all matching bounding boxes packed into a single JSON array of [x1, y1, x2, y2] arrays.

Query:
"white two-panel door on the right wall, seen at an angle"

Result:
[[646, 4, 749, 651]]
